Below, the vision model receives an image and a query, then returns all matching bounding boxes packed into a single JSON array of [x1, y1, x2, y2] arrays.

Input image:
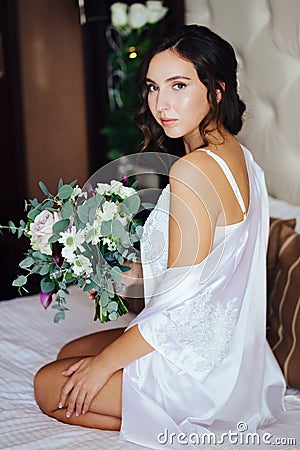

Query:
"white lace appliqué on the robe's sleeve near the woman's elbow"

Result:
[[139, 289, 238, 379]]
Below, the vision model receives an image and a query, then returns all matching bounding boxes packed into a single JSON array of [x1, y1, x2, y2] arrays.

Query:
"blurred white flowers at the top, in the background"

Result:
[[110, 0, 168, 32]]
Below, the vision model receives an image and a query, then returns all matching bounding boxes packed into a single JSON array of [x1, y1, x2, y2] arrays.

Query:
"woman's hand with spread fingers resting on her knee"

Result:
[[58, 356, 112, 418]]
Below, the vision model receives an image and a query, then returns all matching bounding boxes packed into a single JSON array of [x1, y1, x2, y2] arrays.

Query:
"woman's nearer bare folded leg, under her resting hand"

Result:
[[34, 358, 122, 430]]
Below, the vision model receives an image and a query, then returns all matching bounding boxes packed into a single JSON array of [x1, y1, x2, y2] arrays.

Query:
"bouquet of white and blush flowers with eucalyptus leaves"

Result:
[[1, 180, 143, 322]]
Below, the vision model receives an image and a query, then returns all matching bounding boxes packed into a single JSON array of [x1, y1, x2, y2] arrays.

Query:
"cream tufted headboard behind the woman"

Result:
[[185, 0, 300, 205]]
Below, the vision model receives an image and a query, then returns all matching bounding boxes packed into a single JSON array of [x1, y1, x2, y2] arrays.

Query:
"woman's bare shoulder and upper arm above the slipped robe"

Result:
[[168, 154, 222, 267]]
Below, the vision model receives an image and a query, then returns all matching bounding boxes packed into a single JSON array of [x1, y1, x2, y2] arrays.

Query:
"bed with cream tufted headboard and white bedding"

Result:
[[0, 0, 300, 450]]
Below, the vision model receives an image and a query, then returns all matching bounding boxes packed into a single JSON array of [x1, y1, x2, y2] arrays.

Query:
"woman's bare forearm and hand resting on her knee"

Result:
[[58, 325, 153, 417]]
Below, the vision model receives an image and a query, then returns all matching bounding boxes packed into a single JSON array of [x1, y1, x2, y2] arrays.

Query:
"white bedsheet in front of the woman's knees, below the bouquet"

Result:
[[0, 288, 141, 450]]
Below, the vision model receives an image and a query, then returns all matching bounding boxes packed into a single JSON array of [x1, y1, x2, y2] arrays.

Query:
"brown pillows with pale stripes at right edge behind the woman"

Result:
[[267, 218, 300, 389]]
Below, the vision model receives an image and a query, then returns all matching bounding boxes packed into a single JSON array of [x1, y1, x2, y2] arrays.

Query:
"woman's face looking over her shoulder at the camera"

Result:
[[146, 50, 210, 147]]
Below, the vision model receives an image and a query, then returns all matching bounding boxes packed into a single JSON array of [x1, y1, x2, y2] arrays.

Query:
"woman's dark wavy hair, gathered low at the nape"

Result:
[[135, 25, 246, 151]]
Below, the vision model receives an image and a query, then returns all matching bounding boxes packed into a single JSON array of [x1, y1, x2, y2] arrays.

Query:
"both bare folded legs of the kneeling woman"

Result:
[[34, 328, 124, 430]]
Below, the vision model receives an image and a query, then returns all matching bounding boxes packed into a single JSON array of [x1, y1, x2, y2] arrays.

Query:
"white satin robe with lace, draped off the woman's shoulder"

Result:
[[120, 147, 300, 450]]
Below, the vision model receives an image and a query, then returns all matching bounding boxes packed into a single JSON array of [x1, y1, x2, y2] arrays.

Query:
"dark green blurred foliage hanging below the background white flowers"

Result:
[[101, 25, 155, 160]]
